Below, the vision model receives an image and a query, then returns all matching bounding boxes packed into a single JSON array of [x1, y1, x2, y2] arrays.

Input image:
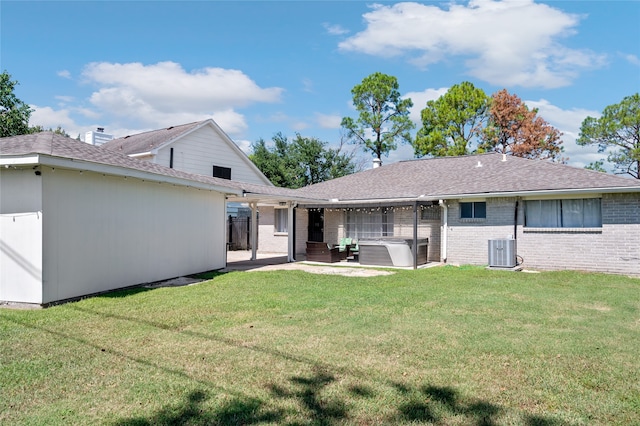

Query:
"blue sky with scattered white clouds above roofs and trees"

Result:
[[0, 0, 640, 167]]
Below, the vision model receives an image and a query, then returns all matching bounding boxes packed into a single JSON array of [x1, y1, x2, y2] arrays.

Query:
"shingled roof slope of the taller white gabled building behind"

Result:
[[100, 120, 202, 155]]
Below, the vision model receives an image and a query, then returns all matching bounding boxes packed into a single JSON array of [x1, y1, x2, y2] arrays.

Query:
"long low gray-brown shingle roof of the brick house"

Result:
[[299, 153, 640, 201]]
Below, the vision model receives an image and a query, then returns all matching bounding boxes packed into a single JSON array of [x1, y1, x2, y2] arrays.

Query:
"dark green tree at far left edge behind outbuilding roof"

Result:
[[0, 71, 33, 137]]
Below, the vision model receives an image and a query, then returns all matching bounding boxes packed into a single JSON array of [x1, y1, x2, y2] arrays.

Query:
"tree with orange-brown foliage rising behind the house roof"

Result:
[[478, 89, 564, 161]]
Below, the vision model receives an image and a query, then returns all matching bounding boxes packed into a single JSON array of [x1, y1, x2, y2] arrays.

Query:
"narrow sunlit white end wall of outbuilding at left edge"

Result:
[[0, 168, 43, 303]]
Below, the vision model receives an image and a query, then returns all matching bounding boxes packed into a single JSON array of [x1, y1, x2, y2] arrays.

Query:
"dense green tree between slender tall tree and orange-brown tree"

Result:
[[413, 81, 489, 157]]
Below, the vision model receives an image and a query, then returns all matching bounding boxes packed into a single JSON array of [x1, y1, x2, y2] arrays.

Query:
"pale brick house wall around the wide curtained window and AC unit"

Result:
[[447, 193, 640, 276]]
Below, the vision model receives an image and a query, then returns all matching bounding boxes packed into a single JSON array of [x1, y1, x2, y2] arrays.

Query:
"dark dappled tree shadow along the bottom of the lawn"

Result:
[[113, 376, 564, 426]]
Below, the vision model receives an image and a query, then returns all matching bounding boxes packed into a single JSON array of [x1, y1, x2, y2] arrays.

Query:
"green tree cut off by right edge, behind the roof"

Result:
[[576, 93, 640, 179]]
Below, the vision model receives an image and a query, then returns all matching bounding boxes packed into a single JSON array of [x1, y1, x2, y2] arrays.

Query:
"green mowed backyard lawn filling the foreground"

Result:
[[0, 267, 640, 425]]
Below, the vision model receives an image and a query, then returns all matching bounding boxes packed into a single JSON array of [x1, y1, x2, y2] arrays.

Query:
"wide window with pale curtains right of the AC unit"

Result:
[[525, 198, 602, 228]]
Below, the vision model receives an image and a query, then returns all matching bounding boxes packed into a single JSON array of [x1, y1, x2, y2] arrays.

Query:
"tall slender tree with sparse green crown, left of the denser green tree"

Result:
[[342, 72, 414, 160]]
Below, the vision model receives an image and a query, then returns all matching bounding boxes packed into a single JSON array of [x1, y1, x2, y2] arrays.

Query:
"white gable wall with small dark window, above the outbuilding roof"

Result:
[[156, 126, 266, 185]]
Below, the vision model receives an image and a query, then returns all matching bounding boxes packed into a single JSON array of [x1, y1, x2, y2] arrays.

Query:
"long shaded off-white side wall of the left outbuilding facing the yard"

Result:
[[41, 169, 225, 303]]
